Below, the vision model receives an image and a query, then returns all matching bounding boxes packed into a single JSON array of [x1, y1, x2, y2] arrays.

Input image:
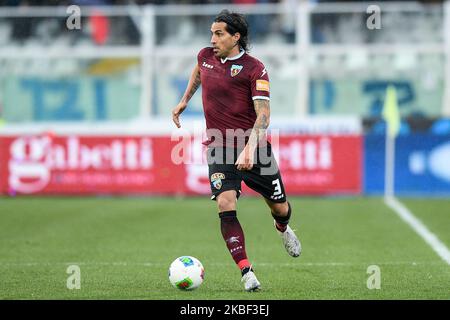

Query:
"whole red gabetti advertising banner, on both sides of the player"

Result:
[[0, 135, 362, 195]]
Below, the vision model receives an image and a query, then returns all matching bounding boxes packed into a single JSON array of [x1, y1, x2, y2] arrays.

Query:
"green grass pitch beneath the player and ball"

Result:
[[0, 197, 450, 300]]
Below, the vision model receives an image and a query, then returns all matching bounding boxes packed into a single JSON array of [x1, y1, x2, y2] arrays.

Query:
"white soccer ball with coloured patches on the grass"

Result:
[[169, 256, 205, 290]]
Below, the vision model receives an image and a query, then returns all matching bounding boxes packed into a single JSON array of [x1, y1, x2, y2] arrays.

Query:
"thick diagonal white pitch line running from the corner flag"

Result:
[[384, 196, 450, 265]]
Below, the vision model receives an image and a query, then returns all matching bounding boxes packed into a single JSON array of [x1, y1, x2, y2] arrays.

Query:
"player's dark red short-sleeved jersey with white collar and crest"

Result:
[[197, 48, 270, 146]]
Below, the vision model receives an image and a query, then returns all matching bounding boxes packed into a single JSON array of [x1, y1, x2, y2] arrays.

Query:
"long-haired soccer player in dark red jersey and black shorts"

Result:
[[172, 10, 301, 291]]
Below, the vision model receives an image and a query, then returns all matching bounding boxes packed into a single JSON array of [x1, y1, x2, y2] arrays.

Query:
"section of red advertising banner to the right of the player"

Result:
[[268, 136, 363, 194]]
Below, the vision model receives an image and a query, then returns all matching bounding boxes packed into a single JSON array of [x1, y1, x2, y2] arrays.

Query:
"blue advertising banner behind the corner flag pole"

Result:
[[364, 134, 450, 195]]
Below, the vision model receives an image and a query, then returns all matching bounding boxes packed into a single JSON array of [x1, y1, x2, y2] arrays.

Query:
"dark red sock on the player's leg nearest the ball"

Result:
[[219, 210, 250, 270]]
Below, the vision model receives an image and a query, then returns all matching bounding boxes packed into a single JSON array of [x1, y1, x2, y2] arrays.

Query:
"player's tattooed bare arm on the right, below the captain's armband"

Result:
[[236, 99, 270, 170]]
